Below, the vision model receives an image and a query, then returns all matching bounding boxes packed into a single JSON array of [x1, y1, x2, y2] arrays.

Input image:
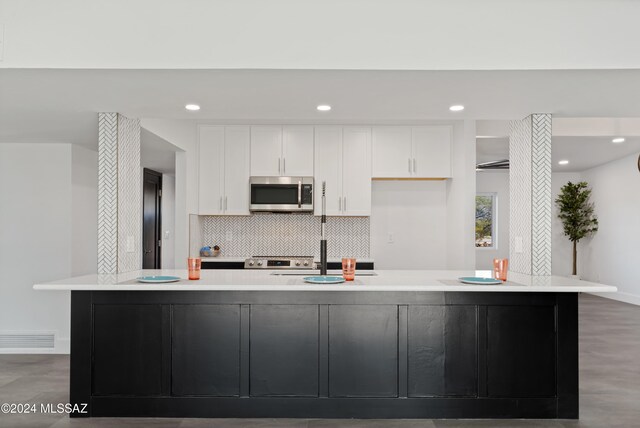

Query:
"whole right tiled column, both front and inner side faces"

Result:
[[509, 114, 551, 275]]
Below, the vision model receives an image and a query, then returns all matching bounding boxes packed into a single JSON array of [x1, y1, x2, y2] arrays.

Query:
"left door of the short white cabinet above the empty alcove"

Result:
[[372, 126, 413, 178]]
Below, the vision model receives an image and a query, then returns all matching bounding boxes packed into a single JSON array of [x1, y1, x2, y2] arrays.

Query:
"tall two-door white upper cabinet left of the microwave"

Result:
[[198, 126, 250, 215]]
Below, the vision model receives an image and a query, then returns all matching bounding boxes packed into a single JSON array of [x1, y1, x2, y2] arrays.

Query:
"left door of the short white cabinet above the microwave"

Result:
[[251, 126, 283, 176]]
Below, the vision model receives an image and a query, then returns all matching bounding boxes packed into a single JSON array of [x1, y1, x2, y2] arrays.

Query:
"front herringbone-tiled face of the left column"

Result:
[[98, 113, 118, 273]]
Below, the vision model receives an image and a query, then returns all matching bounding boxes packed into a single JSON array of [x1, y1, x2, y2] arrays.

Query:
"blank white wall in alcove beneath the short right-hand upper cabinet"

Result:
[[371, 181, 447, 269]]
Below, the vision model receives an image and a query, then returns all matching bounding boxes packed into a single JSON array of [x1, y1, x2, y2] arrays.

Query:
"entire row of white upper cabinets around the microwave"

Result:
[[198, 125, 452, 216]]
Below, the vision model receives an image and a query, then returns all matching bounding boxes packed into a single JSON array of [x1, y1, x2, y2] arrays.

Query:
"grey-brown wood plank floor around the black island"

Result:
[[0, 295, 640, 428]]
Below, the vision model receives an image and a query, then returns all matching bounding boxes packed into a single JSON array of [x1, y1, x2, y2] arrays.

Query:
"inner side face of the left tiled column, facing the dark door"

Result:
[[118, 114, 142, 272]]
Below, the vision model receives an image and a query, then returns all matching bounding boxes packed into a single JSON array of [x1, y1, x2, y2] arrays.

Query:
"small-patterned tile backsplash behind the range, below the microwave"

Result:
[[201, 213, 370, 258]]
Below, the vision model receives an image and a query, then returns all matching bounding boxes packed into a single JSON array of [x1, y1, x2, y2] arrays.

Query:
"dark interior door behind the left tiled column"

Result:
[[142, 168, 162, 269]]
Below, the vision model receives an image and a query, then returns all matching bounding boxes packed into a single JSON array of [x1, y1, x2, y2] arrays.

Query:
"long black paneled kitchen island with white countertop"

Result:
[[34, 270, 616, 418]]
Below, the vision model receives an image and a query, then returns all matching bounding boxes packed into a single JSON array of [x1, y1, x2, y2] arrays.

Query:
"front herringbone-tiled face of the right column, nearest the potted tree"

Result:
[[531, 114, 552, 276]]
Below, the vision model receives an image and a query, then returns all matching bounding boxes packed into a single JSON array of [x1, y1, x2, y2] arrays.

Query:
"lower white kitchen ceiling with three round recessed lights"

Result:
[[0, 69, 640, 147]]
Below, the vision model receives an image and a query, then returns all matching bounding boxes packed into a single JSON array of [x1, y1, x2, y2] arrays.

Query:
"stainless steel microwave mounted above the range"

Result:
[[249, 177, 313, 212]]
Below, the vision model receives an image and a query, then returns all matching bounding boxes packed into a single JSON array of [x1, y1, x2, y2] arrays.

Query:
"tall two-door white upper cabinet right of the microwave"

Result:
[[314, 126, 371, 216]]
